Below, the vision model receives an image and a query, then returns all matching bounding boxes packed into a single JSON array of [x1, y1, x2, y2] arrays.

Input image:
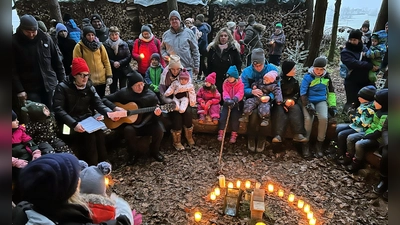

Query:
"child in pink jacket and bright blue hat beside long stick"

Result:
[[218, 66, 244, 144]]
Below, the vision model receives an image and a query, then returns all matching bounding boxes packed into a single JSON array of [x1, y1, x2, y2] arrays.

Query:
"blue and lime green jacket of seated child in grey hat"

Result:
[[300, 67, 336, 107]]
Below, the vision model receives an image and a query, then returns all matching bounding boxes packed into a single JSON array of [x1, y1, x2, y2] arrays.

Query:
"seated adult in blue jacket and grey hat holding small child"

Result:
[[241, 48, 278, 152]]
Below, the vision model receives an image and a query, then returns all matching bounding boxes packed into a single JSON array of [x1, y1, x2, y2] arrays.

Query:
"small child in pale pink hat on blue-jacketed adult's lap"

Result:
[[243, 71, 282, 127]]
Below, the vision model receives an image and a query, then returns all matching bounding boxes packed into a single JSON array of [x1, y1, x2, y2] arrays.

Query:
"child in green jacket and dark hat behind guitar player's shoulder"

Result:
[[144, 53, 164, 99]]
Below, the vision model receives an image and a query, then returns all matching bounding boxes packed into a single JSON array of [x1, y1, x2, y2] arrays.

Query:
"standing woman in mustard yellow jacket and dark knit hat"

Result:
[[72, 26, 113, 98]]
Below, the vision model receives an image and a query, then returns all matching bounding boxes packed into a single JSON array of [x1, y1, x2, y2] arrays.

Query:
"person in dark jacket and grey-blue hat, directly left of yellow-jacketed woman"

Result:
[[56, 23, 76, 74]]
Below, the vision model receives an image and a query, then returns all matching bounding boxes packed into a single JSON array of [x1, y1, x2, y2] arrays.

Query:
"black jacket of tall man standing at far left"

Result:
[[11, 28, 65, 93]]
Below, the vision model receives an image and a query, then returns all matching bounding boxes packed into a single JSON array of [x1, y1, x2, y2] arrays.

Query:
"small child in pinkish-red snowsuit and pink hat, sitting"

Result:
[[196, 72, 221, 124]]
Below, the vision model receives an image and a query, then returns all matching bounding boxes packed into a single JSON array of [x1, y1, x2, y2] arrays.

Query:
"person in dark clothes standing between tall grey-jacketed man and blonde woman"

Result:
[[195, 14, 211, 80]]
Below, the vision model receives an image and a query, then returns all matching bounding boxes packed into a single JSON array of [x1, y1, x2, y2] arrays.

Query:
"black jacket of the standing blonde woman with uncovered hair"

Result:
[[207, 41, 242, 92]]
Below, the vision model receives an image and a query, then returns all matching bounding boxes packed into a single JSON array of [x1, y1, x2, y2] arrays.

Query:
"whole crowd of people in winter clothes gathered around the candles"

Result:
[[12, 10, 388, 224]]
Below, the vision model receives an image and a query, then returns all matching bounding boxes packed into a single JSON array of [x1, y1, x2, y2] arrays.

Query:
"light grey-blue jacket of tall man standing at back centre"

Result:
[[161, 24, 200, 69]]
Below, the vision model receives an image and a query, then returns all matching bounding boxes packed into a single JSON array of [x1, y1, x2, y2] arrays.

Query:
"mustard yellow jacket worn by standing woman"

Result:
[[72, 41, 112, 86]]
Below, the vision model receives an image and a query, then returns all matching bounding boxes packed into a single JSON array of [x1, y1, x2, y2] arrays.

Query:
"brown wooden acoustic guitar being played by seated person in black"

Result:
[[104, 102, 176, 129]]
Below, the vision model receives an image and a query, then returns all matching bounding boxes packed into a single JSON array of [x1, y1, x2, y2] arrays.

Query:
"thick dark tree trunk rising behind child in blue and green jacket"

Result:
[[305, 0, 328, 67]]
